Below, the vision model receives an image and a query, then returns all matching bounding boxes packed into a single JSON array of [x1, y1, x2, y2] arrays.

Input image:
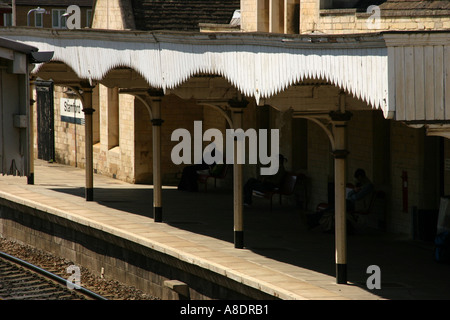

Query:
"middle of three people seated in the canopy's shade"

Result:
[[244, 154, 286, 206]]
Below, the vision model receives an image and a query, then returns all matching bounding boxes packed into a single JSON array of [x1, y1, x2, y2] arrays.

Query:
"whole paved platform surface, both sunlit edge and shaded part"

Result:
[[0, 160, 450, 300]]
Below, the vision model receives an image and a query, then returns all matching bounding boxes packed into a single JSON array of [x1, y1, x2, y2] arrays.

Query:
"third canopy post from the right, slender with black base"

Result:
[[150, 92, 164, 222]]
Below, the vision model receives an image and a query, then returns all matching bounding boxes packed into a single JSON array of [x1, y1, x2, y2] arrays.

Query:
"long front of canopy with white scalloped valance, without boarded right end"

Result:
[[0, 29, 392, 117]]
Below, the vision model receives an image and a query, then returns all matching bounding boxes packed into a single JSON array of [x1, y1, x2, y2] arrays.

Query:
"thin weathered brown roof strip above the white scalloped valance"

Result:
[[1, 27, 386, 48]]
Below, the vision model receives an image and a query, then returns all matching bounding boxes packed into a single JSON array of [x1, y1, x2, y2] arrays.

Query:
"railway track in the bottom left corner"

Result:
[[0, 252, 106, 300]]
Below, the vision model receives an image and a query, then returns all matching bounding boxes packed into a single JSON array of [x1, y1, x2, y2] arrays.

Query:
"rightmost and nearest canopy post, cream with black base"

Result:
[[330, 112, 351, 284]]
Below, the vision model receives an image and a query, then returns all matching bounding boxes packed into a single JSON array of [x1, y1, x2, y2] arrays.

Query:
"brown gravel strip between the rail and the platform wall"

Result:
[[0, 238, 160, 300]]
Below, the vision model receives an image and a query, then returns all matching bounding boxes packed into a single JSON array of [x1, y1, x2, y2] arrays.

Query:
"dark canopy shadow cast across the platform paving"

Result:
[[52, 186, 450, 300]]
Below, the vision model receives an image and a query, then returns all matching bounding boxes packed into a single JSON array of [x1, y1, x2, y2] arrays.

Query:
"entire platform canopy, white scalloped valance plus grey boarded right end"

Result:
[[0, 28, 450, 120]]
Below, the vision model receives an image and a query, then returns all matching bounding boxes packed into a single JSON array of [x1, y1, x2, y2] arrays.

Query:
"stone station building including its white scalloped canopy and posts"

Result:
[[2, 0, 450, 282]]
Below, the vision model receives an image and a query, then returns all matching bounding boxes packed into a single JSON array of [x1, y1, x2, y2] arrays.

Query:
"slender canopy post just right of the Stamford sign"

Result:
[[82, 86, 95, 201]]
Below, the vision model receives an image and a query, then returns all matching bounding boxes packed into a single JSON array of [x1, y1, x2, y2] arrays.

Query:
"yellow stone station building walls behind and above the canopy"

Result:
[[30, 0, 450, 235]]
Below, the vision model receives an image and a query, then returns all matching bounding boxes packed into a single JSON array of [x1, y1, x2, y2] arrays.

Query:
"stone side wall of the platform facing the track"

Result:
[[0, 199, 276, 300]]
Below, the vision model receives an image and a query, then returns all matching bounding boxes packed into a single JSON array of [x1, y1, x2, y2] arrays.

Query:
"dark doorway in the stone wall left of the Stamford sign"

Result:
[[36, 81, 55, 161]]
